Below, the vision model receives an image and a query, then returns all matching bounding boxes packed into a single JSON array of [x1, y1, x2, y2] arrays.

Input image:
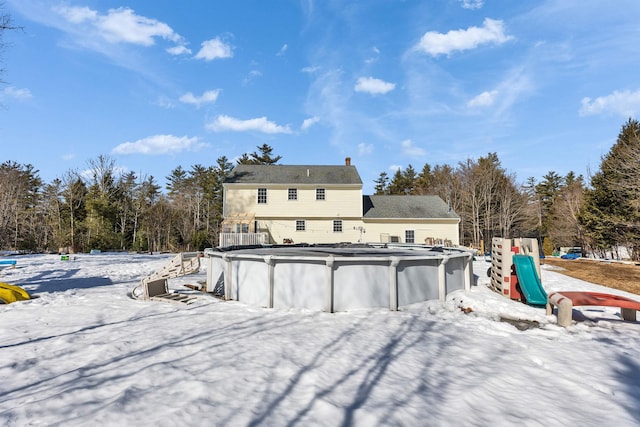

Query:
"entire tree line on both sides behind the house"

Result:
[[0, 119, 640, 260]]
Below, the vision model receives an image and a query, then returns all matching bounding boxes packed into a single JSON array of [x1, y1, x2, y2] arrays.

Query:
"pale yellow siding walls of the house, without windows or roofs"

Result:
[[224, 184, 459, 245]]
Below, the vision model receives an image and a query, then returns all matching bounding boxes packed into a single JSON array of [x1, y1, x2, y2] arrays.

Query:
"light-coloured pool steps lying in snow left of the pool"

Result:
[[131, 252, 200, 304]]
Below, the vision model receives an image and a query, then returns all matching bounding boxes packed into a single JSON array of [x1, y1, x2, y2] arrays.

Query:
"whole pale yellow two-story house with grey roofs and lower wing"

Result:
[[220, 158, 460, 246]]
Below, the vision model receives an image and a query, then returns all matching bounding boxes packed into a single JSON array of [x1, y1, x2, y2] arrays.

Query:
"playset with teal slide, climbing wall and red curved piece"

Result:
[[489, 237, 640, 327]]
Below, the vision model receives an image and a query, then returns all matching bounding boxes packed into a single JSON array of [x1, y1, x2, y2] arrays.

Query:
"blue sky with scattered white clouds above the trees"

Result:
[[0, 0, 640, 193]]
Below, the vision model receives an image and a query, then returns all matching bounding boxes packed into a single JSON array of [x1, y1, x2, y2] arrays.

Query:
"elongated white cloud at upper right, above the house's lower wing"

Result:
[[416, 18, 513, 56]]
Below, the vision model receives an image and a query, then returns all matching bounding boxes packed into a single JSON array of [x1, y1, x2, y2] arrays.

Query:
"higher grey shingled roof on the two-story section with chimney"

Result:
[[224, 165, 362, 185]]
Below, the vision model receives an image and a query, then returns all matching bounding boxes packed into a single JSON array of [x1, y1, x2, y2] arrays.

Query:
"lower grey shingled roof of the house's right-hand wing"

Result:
[[363, 195, 460, 219]]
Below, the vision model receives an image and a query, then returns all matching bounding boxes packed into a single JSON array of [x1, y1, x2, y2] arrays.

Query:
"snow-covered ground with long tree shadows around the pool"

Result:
[[0, 254, 640, 426]]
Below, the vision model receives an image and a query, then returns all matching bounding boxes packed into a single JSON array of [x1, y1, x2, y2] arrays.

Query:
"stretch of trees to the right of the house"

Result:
[[375, 118, 640, 261]]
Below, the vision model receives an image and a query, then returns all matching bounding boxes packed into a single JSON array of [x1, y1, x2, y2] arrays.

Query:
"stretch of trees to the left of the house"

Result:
[[0, 144, 281, 252]]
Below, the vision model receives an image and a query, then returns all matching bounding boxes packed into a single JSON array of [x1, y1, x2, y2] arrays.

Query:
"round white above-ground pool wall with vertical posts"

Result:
[[205, 247, 473, 312]]
